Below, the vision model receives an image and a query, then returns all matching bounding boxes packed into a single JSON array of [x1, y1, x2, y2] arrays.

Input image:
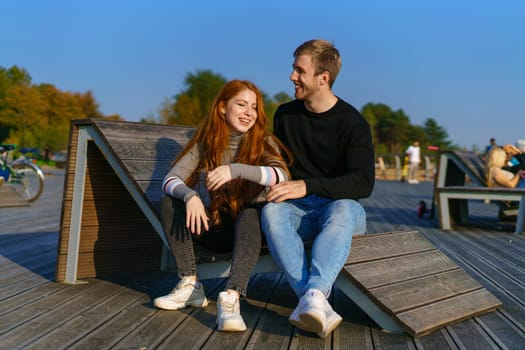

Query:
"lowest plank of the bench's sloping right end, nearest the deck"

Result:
[[397, 289, 501, 336]]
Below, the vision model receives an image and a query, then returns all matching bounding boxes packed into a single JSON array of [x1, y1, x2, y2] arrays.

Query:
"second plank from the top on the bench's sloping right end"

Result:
[[344, 250, 457, 289]]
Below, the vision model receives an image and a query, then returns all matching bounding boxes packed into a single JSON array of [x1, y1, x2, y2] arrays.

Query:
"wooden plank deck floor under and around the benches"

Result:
[[0, 171, 525, 349]]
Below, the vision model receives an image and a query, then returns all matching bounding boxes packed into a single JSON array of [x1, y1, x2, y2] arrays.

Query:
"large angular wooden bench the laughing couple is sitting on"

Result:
[[56, 120, 501, 336]]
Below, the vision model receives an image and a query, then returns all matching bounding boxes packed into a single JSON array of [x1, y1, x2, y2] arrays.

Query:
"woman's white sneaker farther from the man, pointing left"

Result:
[[153, 277, 208, 310]]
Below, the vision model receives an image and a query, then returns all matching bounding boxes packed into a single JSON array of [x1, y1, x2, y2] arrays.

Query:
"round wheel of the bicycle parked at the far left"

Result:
[[10, 162, 44, 202]]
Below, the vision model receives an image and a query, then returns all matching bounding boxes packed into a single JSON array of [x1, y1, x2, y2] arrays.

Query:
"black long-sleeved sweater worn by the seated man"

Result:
[[274, 99, 375, 199]]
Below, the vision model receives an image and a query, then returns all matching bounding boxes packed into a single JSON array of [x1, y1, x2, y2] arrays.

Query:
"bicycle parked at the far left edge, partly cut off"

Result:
[[0, 144, 44, 202]]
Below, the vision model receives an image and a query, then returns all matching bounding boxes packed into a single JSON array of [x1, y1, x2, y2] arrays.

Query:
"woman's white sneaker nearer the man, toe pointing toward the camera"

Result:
[[217, 292, 246, 332]]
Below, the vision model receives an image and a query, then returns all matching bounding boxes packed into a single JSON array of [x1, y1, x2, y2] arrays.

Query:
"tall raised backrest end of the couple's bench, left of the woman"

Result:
[[55, 119, 190, 283]]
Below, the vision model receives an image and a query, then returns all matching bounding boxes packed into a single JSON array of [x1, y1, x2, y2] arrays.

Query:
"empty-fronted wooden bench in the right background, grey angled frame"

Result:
[[435, 151, 525, 233]]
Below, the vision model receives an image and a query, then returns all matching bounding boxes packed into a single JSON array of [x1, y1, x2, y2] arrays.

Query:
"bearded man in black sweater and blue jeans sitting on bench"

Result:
[[262, 40, 375, 337]]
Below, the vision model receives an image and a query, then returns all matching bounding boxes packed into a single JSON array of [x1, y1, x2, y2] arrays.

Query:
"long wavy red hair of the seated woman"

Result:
[[176, 80, 292, 223]]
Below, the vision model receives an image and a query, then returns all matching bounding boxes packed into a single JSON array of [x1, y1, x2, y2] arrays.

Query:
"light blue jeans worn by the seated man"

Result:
[[261, 195, 366, 297]]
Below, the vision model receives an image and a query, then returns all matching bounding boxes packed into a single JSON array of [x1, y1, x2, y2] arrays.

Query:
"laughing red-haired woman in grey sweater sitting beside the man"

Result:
[[154, 80, 289, 331]]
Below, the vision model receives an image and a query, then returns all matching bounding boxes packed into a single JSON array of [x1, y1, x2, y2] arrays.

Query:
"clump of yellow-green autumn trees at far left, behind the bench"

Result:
[[0, 66, 122, 151]]
